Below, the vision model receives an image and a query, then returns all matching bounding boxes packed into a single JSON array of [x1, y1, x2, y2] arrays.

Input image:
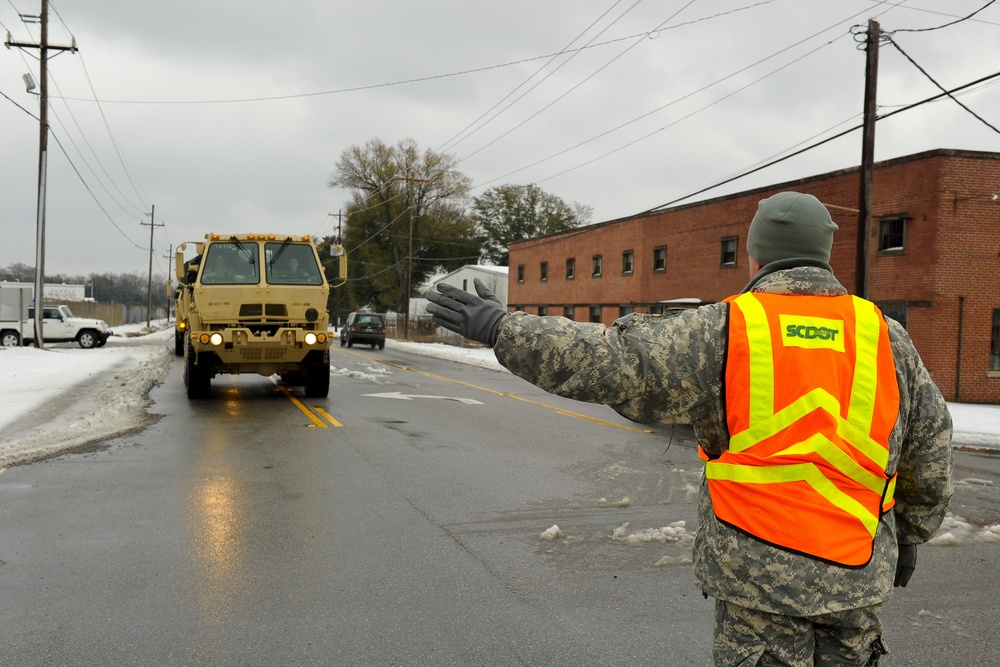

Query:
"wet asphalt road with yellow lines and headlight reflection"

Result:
[[0, 348, 1000, 666]]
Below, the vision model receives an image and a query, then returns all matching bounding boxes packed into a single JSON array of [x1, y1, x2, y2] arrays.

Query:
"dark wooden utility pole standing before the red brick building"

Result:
[[854, 19, 880, 299]]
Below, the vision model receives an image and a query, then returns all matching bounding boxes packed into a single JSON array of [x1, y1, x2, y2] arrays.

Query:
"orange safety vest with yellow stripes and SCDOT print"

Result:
[[700, 293, 899, 567]]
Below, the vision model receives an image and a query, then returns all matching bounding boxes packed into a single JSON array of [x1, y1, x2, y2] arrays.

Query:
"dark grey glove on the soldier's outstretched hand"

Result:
[[427, 278, 507, 347]]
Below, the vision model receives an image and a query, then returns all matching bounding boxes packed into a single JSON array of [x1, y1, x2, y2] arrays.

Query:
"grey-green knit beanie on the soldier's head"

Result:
[[747, 192, 839, 266]]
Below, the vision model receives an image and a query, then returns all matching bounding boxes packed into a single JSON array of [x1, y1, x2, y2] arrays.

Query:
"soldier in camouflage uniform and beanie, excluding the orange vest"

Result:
[[428, 193, 952, 667]]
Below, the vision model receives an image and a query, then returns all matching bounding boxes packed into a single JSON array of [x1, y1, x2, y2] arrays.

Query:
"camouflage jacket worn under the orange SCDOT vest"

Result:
[[494, 267, 952, 616]]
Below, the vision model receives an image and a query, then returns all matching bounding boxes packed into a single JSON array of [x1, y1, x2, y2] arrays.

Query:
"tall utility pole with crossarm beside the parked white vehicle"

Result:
[[4, 0, 77, 348]]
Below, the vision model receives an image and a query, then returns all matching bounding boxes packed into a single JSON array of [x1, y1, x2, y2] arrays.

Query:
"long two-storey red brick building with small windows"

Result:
[[508, 149, 1000, 403]]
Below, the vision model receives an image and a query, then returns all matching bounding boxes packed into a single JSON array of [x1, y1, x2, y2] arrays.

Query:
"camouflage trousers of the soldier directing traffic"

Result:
[[712, 600, 889, 667]]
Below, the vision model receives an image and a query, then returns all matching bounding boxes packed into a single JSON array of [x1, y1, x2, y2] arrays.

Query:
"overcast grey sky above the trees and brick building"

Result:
[[0, 0, 1000, 274]]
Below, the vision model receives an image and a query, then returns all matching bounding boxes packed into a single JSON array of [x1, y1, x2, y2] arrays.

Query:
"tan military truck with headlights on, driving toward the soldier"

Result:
[[174, 234, 347, 399]]
